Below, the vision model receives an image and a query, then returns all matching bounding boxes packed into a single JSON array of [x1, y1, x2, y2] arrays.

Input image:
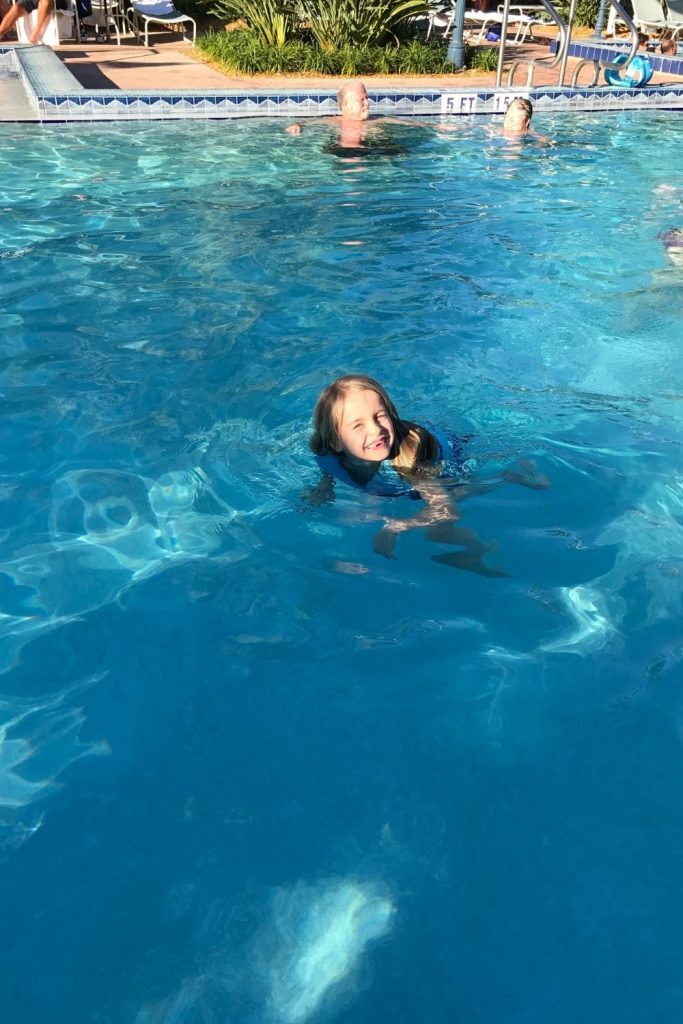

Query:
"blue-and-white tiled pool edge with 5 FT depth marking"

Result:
[[0, 46, 683, 122]]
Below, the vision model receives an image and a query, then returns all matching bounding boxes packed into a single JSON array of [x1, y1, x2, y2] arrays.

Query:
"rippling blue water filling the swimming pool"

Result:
[[0, 114, 683, 1024]]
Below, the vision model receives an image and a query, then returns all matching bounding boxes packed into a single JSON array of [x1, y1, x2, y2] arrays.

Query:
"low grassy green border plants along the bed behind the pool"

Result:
[[197, 32, 453, 76]]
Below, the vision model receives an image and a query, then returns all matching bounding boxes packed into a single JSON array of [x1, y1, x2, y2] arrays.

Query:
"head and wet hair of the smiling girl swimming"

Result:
[[310, 374, 438, 470]]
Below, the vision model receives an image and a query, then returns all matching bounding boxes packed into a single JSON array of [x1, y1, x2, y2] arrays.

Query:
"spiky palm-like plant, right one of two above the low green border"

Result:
[[297, 0, 428, 50]]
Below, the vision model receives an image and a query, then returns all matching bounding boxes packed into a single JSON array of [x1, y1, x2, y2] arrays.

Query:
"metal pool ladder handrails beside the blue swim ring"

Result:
[[496, 0, 638, 89]]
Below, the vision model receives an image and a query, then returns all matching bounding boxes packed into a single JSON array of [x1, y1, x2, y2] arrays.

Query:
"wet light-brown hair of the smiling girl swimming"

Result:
[[309, 374, 438, 471]]
